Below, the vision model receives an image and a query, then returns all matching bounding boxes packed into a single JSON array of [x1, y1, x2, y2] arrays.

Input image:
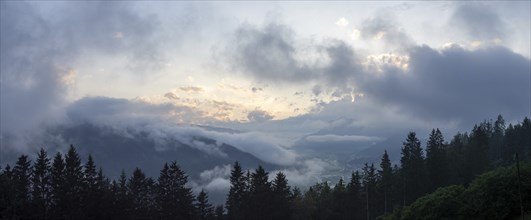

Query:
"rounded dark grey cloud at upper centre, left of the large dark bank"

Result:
[[226, 23, 368, 88]]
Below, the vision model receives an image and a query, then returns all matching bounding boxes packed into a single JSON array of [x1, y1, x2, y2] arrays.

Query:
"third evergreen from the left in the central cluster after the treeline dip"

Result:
[[272, 172, 292, 219]]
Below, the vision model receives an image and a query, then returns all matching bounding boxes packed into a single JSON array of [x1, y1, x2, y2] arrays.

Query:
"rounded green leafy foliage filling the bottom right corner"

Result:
[[381, 164, 531, 219]]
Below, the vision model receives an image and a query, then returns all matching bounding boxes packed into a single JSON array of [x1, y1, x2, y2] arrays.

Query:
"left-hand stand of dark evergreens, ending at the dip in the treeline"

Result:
[[0, 145, 223, 220]]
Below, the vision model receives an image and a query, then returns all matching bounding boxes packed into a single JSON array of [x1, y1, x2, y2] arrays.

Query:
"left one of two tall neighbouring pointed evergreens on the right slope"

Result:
[[400, 132, 427, 204]]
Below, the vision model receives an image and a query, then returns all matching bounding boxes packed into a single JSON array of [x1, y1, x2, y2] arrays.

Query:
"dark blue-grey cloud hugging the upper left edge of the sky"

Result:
[[0, 1, 66, 137]]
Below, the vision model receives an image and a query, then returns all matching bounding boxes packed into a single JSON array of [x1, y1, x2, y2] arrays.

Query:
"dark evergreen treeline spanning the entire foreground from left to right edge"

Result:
[[0, 116, 531, 220]]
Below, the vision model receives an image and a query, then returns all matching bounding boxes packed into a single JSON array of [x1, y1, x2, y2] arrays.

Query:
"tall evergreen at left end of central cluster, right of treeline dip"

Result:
[[226, 162, 248, 220]]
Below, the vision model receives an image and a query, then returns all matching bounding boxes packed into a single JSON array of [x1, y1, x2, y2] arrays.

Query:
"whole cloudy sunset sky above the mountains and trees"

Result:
[[0, 1, 531, 160]]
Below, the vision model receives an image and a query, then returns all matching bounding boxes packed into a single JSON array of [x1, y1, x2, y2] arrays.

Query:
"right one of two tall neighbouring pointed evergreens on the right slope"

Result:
[[426, 128, 448, 192]]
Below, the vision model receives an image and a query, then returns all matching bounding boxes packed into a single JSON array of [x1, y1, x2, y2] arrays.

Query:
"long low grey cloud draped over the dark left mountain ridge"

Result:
[[67, 97, 297, 165]]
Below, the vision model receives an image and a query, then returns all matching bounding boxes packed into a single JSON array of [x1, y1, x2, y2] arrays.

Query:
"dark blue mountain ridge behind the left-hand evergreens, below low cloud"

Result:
[[6, 123, 276, 179]]
